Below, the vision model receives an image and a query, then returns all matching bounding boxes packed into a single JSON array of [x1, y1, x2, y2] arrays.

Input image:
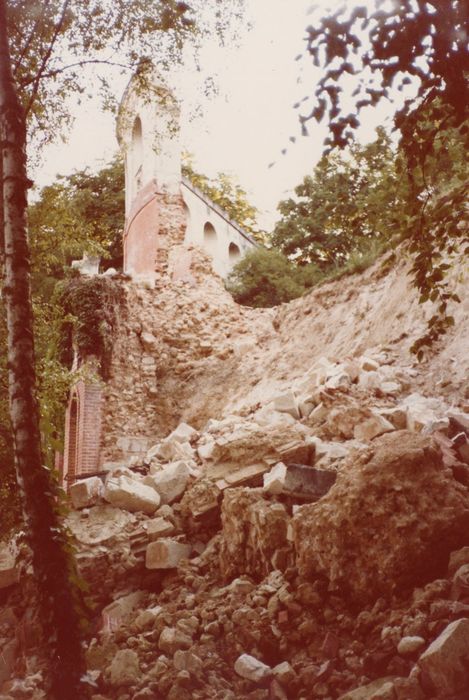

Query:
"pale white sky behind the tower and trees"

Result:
[[35, 0, 398, 228]]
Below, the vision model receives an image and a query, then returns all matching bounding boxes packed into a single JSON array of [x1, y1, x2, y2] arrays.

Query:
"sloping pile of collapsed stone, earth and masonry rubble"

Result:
[[0, 246, 469, 700]]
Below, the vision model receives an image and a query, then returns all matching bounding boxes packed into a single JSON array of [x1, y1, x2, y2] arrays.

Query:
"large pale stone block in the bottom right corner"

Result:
[[418, 618, 469, 697]]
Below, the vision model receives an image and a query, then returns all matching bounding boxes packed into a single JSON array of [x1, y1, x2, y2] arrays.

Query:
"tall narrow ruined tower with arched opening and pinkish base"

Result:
[[117, 64, 185, 277]]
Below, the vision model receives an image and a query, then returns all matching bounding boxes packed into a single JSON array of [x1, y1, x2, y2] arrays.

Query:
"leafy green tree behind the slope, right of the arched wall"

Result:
[[270, 129, 402, 271]]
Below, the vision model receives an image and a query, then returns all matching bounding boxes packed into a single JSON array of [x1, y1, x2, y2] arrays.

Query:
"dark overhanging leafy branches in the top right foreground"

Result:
[[298, 0, 469, 357]]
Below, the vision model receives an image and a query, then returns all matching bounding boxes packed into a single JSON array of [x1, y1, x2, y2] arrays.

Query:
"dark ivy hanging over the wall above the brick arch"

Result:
[[57, 277, 124, 379]]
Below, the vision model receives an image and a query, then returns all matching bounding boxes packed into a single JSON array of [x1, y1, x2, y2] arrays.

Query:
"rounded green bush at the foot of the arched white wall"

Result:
[[226, 248, 321, 307]]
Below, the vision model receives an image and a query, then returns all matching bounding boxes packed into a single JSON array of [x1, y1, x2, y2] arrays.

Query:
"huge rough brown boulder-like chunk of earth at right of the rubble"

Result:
[[292, 431, 469, 602]]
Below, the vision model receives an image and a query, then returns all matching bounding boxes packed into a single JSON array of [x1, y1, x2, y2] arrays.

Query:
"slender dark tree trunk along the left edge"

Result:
[[0, 0, 87, 700]]
